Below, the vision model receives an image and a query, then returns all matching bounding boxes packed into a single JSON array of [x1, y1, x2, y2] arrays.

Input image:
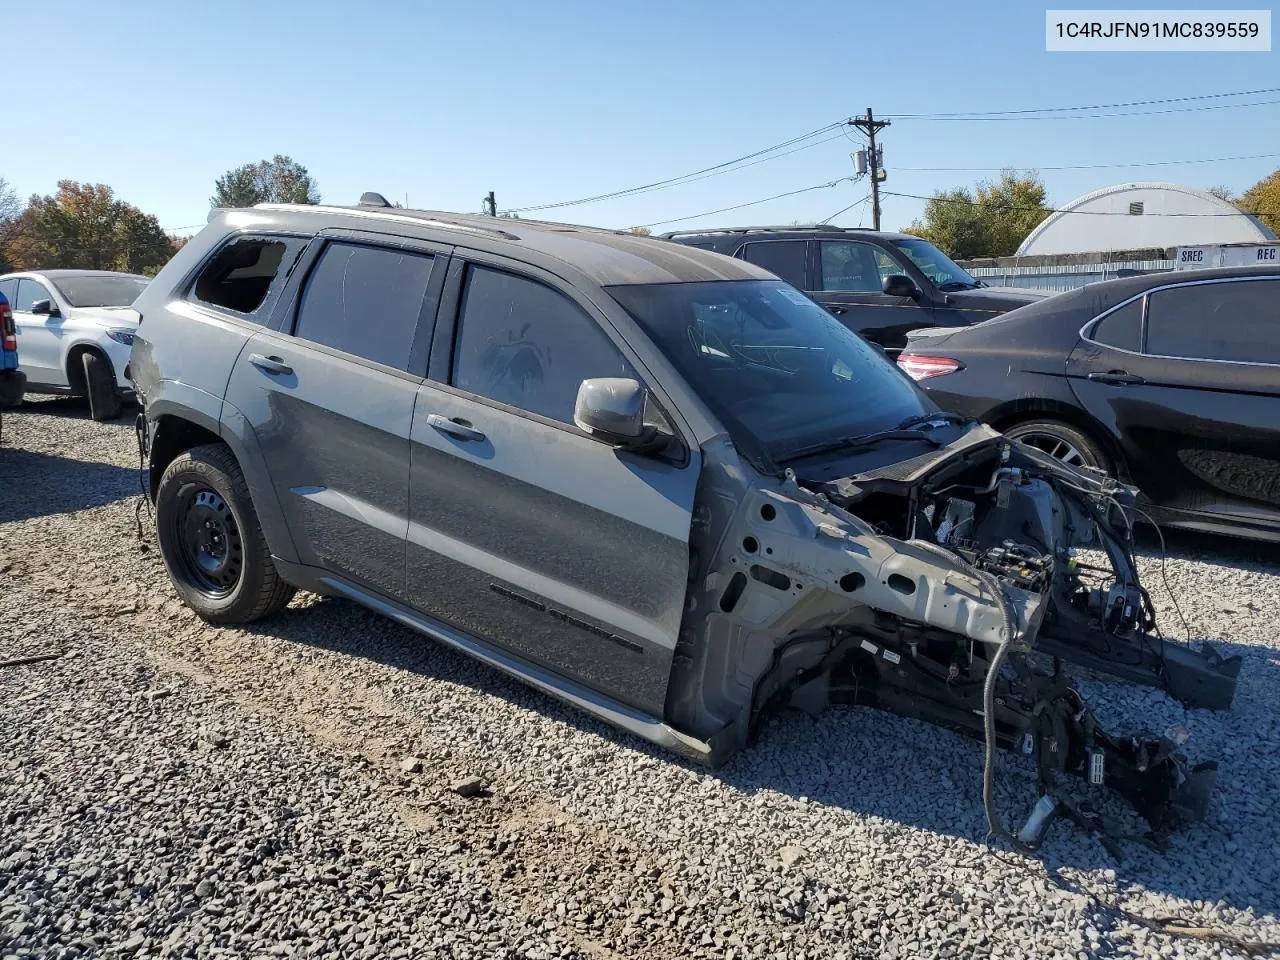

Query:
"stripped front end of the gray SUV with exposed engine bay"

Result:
[[667, 428, 1240, 856]]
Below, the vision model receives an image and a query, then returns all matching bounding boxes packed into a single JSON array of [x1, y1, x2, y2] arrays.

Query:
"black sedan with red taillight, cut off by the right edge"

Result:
[[897, 268, 1280, 541]]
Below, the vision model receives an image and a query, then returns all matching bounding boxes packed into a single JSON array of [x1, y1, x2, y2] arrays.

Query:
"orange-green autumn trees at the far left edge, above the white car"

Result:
[[4, 180, 174, 273]]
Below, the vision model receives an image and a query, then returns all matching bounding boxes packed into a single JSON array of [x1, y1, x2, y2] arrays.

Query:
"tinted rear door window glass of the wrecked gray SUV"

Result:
[[293, 243, 435, 370]]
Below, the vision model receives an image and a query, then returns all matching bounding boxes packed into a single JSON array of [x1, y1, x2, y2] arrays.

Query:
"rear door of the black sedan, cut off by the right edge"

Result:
[[1068, 278, 1280, 535]]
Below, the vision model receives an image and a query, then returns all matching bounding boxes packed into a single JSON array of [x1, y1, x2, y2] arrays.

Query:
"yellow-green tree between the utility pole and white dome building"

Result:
[[904, 170, 1050, 260]]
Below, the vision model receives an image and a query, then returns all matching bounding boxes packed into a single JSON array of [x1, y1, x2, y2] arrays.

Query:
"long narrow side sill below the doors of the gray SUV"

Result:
[[319, 575, 718, 767]]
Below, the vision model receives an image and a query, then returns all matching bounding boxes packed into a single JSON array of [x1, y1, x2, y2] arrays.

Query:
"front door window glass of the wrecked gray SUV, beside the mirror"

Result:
[[453, 266, 635, 424]]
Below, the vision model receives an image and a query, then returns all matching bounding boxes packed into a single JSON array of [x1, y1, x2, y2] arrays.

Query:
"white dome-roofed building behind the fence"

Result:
[[1016, 182, 1276, 257]]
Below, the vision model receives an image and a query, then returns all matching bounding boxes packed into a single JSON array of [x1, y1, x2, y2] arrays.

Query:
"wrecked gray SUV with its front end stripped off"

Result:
[[131, 195, 1240, 849]]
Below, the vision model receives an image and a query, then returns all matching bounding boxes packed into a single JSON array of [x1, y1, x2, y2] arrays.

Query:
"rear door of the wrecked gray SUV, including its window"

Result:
[[227, 230, 449, 598]]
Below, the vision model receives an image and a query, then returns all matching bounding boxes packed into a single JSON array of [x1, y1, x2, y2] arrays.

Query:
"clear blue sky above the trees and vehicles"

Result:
[[0, 0, 1280, 236]]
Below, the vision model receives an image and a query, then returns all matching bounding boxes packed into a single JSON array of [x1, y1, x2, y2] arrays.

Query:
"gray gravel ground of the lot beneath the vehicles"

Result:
[[0, 401, 1280, 960]]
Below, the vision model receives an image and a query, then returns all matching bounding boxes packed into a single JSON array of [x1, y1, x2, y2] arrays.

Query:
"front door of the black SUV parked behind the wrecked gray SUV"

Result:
[[813, 239, 932, 351]]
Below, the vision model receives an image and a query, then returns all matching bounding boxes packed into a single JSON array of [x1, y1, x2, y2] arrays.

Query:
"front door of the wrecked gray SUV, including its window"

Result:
[[408, 255, 699, 716]]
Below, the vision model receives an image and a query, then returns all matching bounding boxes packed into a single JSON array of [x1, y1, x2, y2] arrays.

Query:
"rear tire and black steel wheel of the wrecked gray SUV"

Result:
[[156, 443, 294, 623]]
